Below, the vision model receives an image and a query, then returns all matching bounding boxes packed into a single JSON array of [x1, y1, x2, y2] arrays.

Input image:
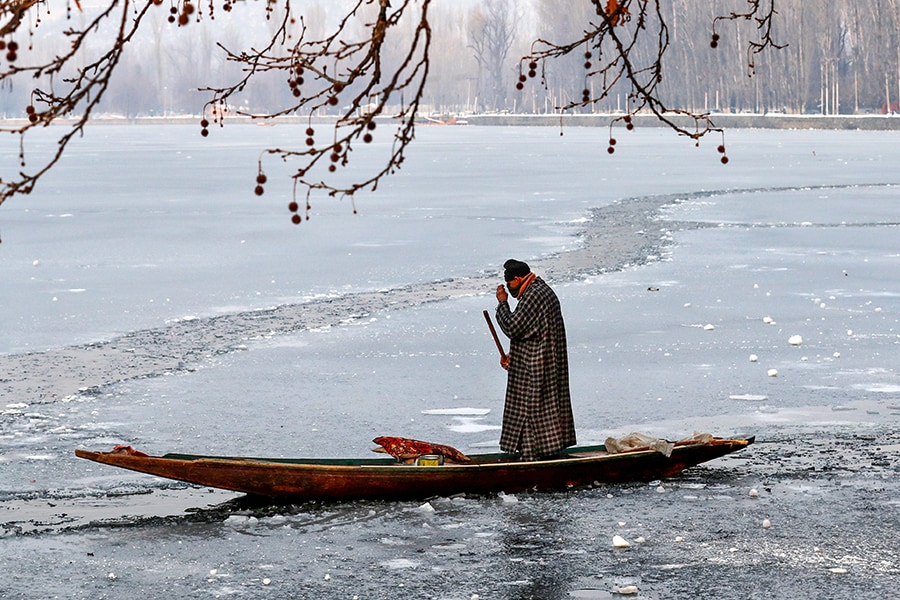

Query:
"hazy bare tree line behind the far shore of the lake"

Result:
[[0, 0, 900, 117]]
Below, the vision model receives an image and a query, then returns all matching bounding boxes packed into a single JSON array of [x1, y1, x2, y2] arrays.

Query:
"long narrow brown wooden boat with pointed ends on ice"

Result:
[[75, 437, 754, 502]]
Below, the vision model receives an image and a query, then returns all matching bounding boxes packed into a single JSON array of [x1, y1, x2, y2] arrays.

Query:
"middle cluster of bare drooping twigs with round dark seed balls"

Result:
[[201, 0, 431, 222]]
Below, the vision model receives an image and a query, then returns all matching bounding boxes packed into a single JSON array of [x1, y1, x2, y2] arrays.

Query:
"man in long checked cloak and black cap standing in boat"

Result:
[[497, 259, 575, 460]]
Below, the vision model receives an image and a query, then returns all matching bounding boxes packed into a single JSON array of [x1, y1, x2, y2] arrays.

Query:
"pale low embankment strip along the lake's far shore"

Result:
[[7, 112, 900, 131]]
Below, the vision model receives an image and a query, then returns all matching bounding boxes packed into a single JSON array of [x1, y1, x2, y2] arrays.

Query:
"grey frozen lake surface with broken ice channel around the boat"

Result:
[[0, 126, 900, 599]]
